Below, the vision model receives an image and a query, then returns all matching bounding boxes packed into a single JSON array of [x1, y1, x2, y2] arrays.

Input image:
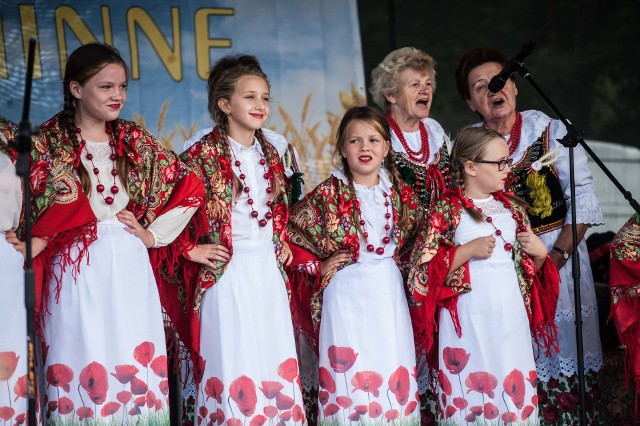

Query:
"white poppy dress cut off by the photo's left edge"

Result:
[[0, 152, 27, 424]]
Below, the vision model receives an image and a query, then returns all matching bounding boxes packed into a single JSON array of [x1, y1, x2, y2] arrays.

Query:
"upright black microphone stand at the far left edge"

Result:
[[13, 38, 37, 425]]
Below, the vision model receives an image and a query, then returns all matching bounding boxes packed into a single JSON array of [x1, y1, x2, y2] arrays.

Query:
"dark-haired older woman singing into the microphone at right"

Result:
[[456, 49, 604, 424]]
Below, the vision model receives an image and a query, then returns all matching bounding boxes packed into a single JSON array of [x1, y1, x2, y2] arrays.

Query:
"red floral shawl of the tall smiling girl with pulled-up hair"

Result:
[[158, 128, 289, 357]]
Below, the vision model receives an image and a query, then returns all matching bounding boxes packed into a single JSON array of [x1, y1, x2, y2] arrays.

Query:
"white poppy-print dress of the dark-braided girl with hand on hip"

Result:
[[41, 141, 195, 424]]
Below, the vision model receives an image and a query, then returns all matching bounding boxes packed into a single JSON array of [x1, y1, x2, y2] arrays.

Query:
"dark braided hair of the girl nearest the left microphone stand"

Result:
[[58, 43, 129, 195]]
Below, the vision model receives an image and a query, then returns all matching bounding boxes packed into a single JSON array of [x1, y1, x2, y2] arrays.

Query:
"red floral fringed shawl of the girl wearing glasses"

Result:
[[407, 188, 559, 362]]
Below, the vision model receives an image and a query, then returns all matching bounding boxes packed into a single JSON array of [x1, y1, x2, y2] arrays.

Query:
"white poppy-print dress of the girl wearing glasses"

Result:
[[438, 197, 538, 425]]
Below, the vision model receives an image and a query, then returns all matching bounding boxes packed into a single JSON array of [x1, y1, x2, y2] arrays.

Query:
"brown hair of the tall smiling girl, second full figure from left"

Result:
[[207, 55, 281, 200]]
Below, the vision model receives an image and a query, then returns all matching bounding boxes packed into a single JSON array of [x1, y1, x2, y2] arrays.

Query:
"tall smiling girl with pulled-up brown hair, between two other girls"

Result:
[[174, 56, 306, 424]]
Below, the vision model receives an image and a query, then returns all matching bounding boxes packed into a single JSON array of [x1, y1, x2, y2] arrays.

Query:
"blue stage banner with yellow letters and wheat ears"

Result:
[[0, 0, 365, 186]]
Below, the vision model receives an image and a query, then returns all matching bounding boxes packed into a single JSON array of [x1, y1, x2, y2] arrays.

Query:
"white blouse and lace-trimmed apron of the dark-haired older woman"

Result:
[[512, 111, 604, 382]]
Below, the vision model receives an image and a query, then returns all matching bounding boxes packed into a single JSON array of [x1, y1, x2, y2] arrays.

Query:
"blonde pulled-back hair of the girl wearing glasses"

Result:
[[449, 127, 527, 222]]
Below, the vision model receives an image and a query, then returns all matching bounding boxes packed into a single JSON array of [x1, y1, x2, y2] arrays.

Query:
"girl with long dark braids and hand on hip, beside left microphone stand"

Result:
[[24, 44, 204, 424]]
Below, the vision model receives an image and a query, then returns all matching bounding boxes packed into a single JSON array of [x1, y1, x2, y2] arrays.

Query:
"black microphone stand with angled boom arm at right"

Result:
[[519, 62, 640, 425]]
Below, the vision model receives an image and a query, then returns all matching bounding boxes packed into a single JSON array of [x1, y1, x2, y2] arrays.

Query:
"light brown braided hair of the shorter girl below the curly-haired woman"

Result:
[[333, 106, 410, 234]]
